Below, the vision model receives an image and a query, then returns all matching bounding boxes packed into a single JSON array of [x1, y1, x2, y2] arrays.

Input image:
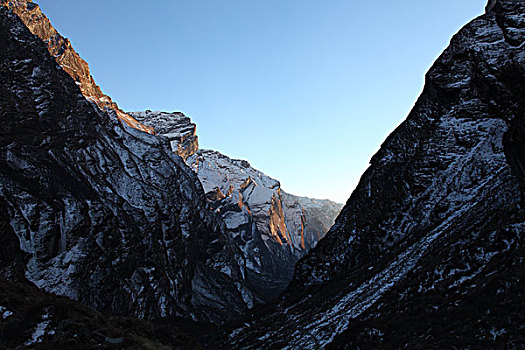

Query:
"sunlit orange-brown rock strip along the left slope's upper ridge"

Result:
[[0, 0, 153, 133]]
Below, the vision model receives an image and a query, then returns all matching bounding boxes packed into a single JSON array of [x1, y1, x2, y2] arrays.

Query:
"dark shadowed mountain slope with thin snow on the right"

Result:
[[225, 0, 525, 349]]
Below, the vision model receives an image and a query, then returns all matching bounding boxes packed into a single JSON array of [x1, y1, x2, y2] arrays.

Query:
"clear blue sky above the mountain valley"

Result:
[[36, 0, 486, 202]]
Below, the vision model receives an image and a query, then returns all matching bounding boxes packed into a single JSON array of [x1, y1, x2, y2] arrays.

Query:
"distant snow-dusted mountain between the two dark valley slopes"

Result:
[[129, 111, 342, 303]]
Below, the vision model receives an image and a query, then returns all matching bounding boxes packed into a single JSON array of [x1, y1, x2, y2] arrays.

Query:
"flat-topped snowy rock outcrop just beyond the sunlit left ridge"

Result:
[[128, 110, 199, 160]]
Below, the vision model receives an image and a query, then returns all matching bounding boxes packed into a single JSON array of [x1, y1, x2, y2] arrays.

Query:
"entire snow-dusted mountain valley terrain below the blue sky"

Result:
[[0, 0, 525, 349]]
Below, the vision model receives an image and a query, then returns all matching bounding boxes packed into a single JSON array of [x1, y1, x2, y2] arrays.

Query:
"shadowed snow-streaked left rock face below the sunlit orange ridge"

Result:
[[0, 5, 252, 323]]
